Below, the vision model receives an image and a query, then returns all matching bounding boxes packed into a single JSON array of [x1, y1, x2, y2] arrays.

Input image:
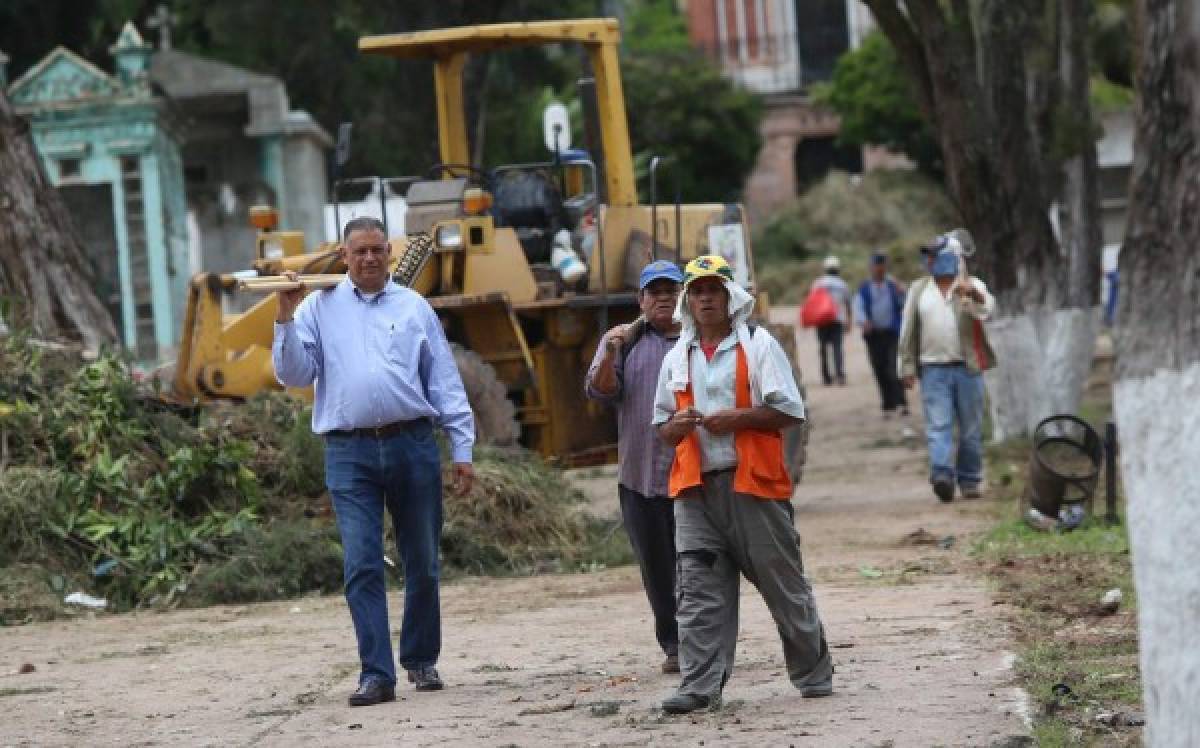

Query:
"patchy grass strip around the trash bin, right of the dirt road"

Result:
[[972, 364, 1142, 746]]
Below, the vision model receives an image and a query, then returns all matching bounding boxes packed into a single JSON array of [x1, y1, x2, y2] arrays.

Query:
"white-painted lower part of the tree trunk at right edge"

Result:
[[1114, 364, 1200, 748]]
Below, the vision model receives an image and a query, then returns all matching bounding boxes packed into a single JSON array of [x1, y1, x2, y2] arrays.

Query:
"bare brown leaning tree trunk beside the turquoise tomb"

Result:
[[0, 89, 116, 351]]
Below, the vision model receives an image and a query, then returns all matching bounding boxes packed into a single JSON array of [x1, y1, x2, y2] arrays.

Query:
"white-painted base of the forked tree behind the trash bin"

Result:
[[984, 309, 1100, 442]]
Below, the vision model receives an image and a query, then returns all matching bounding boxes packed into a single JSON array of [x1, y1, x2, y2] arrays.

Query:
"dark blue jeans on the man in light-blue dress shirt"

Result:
[[325, 421, 442, 683]]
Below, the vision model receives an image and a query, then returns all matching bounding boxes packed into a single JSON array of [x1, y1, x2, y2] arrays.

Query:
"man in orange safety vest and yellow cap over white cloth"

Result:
[[653, 255, 833, 714]]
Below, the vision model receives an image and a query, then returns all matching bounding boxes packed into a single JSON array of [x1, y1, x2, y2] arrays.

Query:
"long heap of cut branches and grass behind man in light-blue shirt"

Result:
[[0, 336, 604, 623]]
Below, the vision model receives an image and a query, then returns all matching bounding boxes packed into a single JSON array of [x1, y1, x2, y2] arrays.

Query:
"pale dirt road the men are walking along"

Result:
[[0, 312, 1026, 747]]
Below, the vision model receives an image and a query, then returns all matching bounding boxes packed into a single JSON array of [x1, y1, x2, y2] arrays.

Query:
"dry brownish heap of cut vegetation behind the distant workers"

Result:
[[754, 169, 959, 304]]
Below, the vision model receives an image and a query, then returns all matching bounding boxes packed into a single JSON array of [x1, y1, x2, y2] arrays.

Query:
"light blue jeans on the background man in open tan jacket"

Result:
[[920, 364, 983, 485]]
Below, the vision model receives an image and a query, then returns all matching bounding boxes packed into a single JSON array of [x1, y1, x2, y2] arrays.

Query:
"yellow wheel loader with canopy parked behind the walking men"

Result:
[[174, 19, 790, 466]]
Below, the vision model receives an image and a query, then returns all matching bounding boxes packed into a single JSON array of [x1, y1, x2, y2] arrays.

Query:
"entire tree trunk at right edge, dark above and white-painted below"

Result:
[[1114, 0, 1200, 746]]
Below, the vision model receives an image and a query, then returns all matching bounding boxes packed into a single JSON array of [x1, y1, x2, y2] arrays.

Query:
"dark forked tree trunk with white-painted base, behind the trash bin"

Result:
[[863, 0, 1100, 439]]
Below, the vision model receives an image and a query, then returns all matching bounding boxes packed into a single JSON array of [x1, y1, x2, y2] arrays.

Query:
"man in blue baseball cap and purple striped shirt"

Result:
[[586, 259, 683, 672]]
